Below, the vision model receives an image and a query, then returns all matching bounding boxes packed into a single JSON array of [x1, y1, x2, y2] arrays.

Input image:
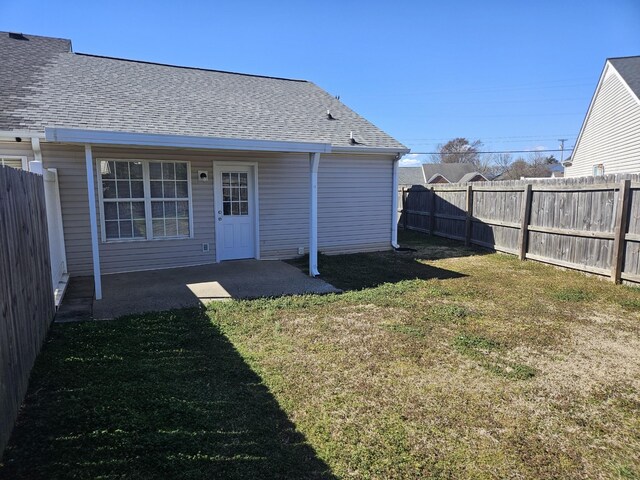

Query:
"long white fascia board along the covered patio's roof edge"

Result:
[[45, 127, 332, 153]]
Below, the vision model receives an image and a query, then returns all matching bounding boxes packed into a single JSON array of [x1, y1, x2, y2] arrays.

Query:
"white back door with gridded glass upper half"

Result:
[[213, 164, 256, 261]]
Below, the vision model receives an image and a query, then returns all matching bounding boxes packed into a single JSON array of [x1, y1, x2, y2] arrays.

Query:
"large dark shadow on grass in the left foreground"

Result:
[[0, 309, 334, 479]]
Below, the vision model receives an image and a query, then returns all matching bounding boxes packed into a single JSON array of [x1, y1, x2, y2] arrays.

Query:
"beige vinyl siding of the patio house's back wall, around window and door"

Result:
[[43, 144, 393, 275]]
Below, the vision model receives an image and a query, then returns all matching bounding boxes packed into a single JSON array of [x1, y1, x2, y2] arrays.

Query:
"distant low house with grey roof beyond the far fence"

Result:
[[398, 163, 488, 188]]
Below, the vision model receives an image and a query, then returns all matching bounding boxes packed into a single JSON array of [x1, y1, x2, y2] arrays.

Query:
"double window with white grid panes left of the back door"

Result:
[[97, 159, 193, 242]]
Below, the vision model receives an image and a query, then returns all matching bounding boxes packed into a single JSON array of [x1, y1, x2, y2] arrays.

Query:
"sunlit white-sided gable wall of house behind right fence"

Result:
[[565, 67, 640, 177]]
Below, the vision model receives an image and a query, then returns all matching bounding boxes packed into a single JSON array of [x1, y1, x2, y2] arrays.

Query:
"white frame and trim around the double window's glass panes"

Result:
[[96, 158, 194, 243]]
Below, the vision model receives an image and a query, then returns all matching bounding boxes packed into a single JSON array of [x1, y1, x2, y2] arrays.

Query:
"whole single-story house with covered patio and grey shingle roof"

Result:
[[0, 33, 408, 298]]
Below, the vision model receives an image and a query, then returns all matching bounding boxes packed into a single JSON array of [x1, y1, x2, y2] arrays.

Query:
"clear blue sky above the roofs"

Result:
[[0, 0, 640, 164]]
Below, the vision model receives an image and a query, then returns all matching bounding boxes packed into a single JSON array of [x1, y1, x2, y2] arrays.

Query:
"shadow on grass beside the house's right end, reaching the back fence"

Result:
[[290, 232, 478, 291]]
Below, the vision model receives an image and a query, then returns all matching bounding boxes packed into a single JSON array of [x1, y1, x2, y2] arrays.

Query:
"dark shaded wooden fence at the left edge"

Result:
[[0, 167, 55, 457]]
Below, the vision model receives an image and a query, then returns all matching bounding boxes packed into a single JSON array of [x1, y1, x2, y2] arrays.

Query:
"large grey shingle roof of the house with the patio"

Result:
[[0, 33, 406, 149]]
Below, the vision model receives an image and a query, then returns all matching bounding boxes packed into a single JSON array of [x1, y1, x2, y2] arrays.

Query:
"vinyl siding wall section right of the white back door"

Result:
[[258, 154, 393, 259]]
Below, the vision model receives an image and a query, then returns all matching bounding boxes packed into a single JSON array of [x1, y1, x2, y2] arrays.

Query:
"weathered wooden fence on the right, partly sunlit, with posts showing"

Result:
[[398, 175, 640, 283]]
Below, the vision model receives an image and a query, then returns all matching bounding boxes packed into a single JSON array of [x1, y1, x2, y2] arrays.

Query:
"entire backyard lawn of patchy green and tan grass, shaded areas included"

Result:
[[0, 231, 640, 479]]
